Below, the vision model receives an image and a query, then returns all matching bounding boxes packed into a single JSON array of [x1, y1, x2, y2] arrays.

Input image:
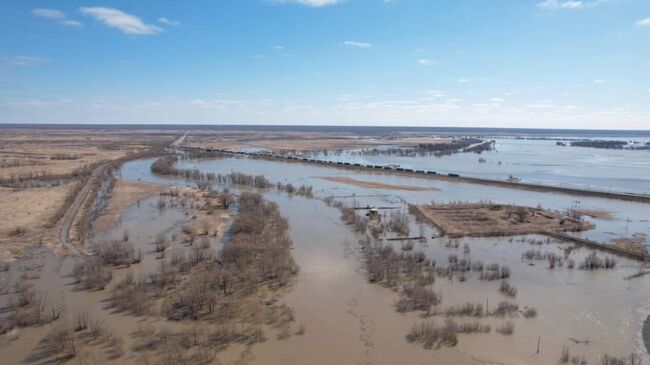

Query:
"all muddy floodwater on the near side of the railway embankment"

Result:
[[0, 151, 650, 364]]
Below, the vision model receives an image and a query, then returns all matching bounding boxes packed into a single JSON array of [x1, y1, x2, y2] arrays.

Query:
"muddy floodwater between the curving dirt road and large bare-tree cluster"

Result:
[[0, 198, 187, 364]]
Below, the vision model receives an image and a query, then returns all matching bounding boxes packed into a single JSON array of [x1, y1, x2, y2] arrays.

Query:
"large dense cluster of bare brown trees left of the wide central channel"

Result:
[[102, 192, 298, 330]]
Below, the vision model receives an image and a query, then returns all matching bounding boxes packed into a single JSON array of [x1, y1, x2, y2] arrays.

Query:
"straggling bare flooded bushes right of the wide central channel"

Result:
[[325, 199, 546, 348]]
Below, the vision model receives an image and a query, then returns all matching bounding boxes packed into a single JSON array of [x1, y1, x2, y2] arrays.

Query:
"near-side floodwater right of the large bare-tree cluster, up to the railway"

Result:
[[116, 158, 650, 364]]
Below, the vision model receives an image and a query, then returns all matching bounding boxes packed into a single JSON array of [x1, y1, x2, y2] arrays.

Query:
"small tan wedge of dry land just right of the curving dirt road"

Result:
[[93, 179, 166, 233]]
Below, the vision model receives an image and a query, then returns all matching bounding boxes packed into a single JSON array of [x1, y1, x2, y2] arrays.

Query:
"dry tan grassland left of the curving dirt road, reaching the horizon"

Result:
[[0, 127, 182, 260]]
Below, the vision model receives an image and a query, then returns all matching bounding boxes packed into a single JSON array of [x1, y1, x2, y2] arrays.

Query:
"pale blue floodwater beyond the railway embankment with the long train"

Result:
[[304, 138, 650, 194]]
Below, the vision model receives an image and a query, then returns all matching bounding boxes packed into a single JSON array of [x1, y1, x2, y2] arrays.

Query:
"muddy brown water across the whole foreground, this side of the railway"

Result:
[[0, 159, 650, 364]]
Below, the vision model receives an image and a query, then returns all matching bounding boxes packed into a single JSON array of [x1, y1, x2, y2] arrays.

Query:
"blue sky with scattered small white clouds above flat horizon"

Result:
[[0, 0, 650, 129]]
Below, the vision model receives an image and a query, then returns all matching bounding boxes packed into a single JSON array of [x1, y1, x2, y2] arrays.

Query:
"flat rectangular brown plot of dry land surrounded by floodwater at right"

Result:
[[414, 200, 594, 237]]
